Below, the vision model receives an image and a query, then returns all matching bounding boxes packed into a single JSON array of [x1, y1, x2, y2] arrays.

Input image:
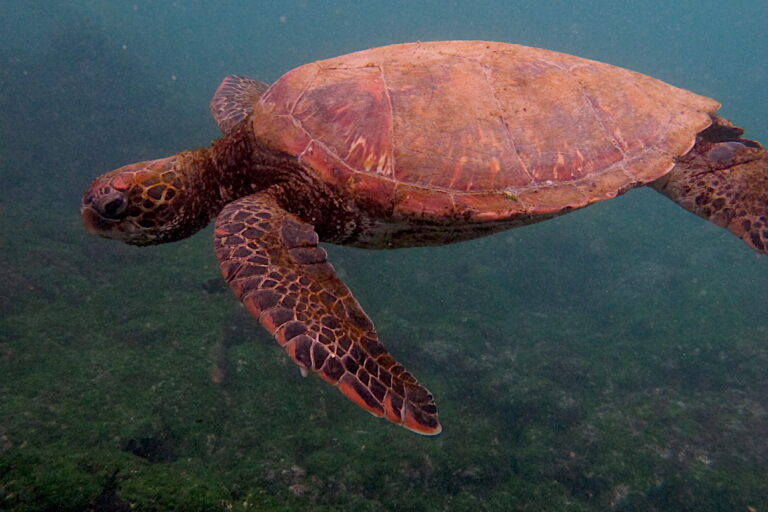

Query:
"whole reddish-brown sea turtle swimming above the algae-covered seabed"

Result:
[[81, 41, 768, 434]]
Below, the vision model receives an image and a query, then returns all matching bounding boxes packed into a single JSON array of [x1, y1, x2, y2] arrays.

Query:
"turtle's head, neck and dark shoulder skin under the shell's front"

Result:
[[81, 127, 361, 246]]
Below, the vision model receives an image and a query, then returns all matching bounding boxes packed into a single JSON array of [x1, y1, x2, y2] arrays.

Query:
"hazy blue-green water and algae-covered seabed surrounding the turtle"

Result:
[[0, 0, 768, 512]]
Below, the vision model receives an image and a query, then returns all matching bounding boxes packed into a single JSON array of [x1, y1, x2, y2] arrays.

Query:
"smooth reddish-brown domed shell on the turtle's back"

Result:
[[248, 41, 720, 220]]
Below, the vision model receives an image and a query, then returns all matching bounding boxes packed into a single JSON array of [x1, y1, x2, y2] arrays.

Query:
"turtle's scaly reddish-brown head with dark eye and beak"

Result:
[[80, 153, 209, 245]]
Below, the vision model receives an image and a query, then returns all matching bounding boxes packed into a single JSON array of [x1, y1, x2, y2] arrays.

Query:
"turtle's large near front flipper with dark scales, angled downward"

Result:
[[215, 193, 441, 434]]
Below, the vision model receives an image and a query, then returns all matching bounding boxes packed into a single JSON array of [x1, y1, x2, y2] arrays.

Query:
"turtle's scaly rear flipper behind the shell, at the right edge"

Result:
[[651, 118, 768, 254]]
